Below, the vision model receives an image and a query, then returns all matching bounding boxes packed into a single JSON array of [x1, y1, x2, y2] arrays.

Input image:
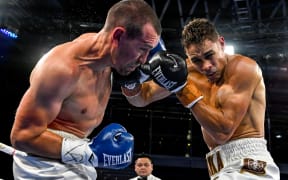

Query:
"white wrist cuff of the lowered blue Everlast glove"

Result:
[[61, 138, 98, 167]]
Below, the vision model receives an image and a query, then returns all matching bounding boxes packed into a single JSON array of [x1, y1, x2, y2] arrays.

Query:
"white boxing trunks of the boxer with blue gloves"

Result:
[[13, 130, 97, 180]]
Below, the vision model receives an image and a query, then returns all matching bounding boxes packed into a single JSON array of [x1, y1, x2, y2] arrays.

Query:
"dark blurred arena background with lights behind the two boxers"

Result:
[[0, 0, 288, 180]]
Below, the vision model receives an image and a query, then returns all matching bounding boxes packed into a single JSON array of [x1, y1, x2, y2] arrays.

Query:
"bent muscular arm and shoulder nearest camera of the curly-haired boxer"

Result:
[[191, 56, 265, 144]]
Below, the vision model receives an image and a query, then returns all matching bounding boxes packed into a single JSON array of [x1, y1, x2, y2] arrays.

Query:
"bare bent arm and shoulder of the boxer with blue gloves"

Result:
[[10, 46, 75, 158]]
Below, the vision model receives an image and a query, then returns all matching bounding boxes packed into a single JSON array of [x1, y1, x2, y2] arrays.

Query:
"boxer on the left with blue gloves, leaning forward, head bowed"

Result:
[[11, 0, 162, 180]]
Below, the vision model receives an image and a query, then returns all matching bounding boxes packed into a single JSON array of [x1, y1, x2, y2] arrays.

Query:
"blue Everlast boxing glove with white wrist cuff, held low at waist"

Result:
[[61, 123, 134, 169]]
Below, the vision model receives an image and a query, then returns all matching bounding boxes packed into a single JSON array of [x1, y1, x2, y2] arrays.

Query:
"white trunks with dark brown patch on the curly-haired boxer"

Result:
[[206, 138, 280, 180]]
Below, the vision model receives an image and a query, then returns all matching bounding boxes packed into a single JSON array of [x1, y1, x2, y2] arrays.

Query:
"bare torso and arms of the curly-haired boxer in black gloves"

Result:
[[127, 55, 266, 149]]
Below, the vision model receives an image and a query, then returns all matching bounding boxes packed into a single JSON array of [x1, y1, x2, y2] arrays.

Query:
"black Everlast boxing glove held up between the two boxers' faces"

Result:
[[140, 51, 188, 93]]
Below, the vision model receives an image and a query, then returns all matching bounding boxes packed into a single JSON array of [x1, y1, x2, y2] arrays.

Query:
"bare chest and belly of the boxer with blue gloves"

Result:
[[48, 67, 112, 137]]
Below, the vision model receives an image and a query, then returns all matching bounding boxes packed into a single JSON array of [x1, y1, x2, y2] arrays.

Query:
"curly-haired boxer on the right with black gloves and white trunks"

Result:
[[122, 18, 280, 180]]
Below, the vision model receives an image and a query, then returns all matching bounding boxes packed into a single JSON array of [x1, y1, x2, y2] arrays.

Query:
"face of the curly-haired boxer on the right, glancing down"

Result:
[[185, 39, 227, 82]]
